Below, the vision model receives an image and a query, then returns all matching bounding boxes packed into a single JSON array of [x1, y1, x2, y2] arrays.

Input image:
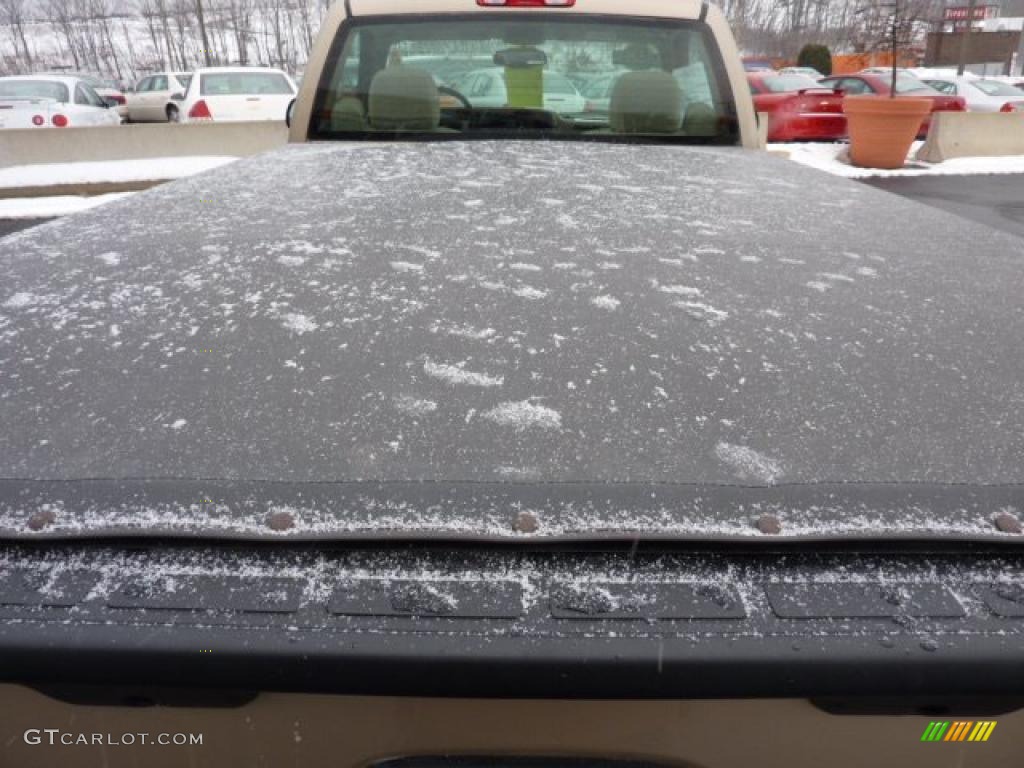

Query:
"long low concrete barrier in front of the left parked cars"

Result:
[[0, 121, 288, 168]]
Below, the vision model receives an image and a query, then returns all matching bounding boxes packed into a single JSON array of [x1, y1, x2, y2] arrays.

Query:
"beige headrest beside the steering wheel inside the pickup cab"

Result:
[[369, 65, 441, 131]]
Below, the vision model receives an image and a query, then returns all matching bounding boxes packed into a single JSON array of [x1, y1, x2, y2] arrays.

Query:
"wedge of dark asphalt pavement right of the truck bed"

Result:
[[864, 173, 1024, 238]]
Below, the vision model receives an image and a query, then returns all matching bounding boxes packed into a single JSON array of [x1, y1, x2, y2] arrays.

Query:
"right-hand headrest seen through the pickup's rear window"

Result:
[[608, 70, 683, 133]]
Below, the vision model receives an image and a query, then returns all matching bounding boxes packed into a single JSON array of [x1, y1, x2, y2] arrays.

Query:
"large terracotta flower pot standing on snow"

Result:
[[843, 96, 932, 169]]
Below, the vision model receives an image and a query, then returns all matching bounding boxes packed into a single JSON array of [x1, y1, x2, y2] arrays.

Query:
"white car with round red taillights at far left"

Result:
[[0, 75, 121, 129]]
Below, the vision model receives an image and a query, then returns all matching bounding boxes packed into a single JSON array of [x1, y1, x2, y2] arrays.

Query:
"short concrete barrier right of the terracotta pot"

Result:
[[915, 112, 1024, 163]]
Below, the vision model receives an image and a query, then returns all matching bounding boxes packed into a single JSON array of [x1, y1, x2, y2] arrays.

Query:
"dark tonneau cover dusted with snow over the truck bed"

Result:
[[0, 141, 1024, 539]]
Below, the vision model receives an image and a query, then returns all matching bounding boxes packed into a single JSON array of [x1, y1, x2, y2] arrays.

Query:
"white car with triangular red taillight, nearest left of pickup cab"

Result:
[[180, 67, 298, 123]]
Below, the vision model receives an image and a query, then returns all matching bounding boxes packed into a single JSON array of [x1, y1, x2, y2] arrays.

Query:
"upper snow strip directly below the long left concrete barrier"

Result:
[[0, 157, 238, 191]]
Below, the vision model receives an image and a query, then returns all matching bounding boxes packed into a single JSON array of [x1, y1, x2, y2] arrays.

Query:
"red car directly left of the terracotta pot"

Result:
[[746, 72, 846, 141]]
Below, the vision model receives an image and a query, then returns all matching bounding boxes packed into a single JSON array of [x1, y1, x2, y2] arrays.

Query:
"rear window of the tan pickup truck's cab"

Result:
[[310, 14, 738, 143]]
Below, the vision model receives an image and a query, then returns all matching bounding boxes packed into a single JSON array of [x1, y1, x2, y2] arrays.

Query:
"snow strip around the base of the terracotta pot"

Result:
[[768, 141, 1024, 178]]
